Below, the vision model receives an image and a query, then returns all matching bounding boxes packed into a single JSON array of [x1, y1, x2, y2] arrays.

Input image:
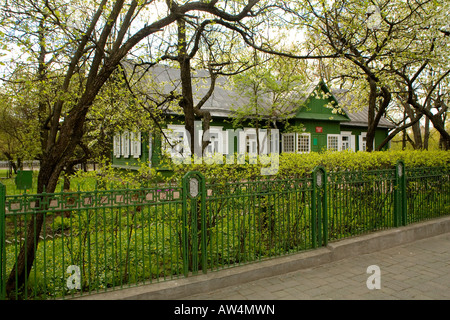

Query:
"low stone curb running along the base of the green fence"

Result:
[[74, 217, 450, 300]]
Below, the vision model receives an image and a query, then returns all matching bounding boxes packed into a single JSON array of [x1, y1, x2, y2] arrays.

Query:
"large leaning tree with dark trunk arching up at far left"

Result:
[[2, 0, 259, 292]]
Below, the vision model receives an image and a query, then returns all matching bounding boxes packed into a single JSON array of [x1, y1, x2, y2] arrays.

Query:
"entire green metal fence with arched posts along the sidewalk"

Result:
[[0, 162, 450, 299]]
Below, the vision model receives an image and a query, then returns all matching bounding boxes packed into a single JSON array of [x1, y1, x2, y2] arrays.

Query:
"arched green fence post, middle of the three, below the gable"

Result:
[[311, 167, 328, 248]]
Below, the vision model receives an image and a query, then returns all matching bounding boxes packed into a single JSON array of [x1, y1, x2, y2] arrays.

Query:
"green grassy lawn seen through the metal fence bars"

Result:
[[1, 166, 450, 299]]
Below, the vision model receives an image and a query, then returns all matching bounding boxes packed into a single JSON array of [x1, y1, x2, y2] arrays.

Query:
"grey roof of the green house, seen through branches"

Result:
[[126, 64, 395, 128]]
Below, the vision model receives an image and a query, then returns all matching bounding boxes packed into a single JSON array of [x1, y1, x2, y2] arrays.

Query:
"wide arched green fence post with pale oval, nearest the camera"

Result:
[[182, 171, 207, 276]]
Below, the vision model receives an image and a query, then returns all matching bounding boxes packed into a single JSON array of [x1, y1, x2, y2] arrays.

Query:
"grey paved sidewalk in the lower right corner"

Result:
[[182, 233, 450, 300]]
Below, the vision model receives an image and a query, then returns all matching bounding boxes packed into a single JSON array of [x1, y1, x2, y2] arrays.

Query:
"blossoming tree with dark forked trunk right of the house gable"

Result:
[[286, 0, 448, 151]]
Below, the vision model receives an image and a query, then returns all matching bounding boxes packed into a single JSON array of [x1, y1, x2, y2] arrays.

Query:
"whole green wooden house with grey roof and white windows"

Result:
[[112, 65, 395, 169]]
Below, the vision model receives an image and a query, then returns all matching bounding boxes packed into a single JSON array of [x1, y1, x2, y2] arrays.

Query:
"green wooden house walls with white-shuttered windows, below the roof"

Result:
[[113, 85, 394, 170]]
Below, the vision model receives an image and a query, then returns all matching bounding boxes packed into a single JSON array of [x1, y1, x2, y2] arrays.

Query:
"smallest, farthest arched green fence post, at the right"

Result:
[[394, 160, 407, 227]]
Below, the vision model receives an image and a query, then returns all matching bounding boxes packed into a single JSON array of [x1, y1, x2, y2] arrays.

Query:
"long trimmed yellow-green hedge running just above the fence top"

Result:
[[77, 150, 450, 190]]
